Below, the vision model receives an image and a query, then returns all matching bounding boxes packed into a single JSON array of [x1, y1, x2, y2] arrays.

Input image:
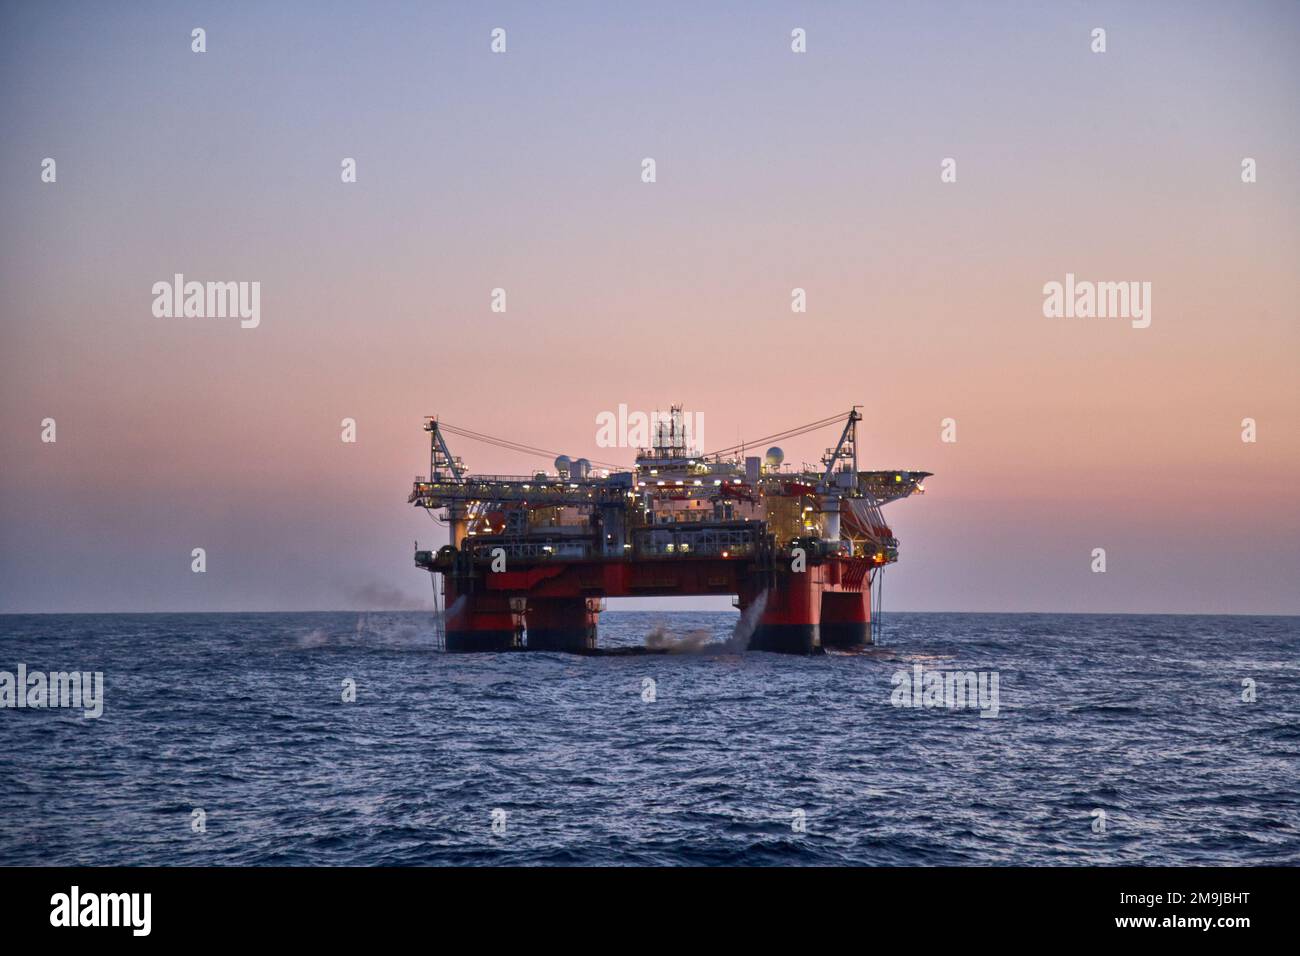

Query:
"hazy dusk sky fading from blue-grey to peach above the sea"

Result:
[[0, 3, 1300, 614]]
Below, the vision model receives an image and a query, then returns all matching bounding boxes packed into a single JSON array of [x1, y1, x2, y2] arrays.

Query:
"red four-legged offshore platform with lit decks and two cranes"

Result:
[[410, 407, 930, 654]]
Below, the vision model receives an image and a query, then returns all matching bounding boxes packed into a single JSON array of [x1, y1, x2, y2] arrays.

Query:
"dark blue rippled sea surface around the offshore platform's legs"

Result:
[[0, 611, 1300, 865]]
